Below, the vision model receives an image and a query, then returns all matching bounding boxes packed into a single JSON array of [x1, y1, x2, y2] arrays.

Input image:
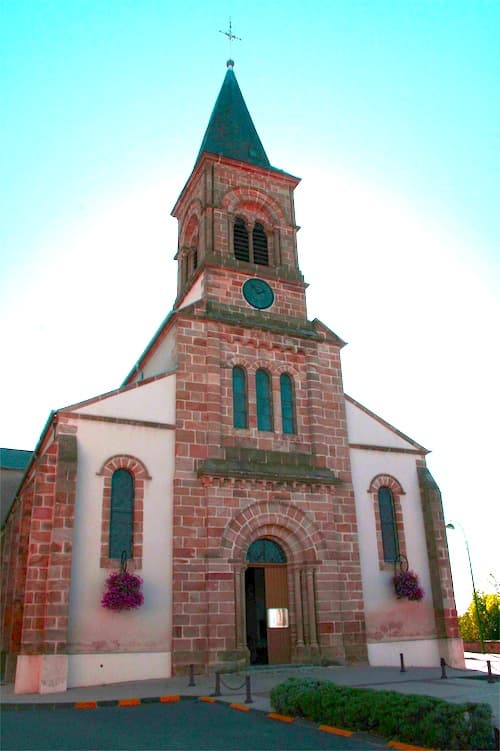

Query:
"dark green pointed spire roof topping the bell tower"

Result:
[[196, 60, 271, 168]]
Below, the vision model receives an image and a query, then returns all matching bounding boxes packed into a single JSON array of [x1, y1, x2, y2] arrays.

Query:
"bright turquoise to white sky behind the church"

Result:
[[0, 0, 500, 612]]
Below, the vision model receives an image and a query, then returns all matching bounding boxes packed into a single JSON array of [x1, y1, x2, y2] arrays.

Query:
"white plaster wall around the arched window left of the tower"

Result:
[[68, 420, 175, 685]]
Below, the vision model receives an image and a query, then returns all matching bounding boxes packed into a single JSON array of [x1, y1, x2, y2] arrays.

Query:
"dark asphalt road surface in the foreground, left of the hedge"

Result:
[[2, 698, 388, 751]]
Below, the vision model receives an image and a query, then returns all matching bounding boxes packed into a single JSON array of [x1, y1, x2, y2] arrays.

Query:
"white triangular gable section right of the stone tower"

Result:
[[345, 394, 428, 454]]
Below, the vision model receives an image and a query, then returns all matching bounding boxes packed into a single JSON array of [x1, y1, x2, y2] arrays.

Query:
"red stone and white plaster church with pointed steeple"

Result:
[[1, 60, 463, 693]]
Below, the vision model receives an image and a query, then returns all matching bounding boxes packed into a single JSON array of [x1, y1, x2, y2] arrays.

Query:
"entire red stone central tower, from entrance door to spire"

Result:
[[169, 61, 366, 672]]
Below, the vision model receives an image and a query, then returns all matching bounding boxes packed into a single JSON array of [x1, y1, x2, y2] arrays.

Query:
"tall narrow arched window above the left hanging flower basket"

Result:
[[109, 469, 134, 558]]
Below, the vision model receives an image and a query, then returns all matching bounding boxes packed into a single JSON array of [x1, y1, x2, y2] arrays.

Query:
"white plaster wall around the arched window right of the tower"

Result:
[[350, 449, 436, 664]]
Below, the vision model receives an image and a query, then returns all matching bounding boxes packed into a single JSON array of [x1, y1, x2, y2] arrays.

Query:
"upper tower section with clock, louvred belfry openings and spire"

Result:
[[172, 60, 307, 320]]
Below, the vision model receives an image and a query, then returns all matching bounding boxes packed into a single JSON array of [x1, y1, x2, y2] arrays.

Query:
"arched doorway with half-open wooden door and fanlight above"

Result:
[[245, 537, 290, 665]]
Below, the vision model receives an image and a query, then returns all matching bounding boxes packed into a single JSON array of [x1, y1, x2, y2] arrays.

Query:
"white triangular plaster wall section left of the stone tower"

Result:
[[73, 373, 175, 425]]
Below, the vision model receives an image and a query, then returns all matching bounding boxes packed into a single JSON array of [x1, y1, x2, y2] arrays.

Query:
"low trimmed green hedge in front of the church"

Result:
[[271, 678, 495, 749]]
